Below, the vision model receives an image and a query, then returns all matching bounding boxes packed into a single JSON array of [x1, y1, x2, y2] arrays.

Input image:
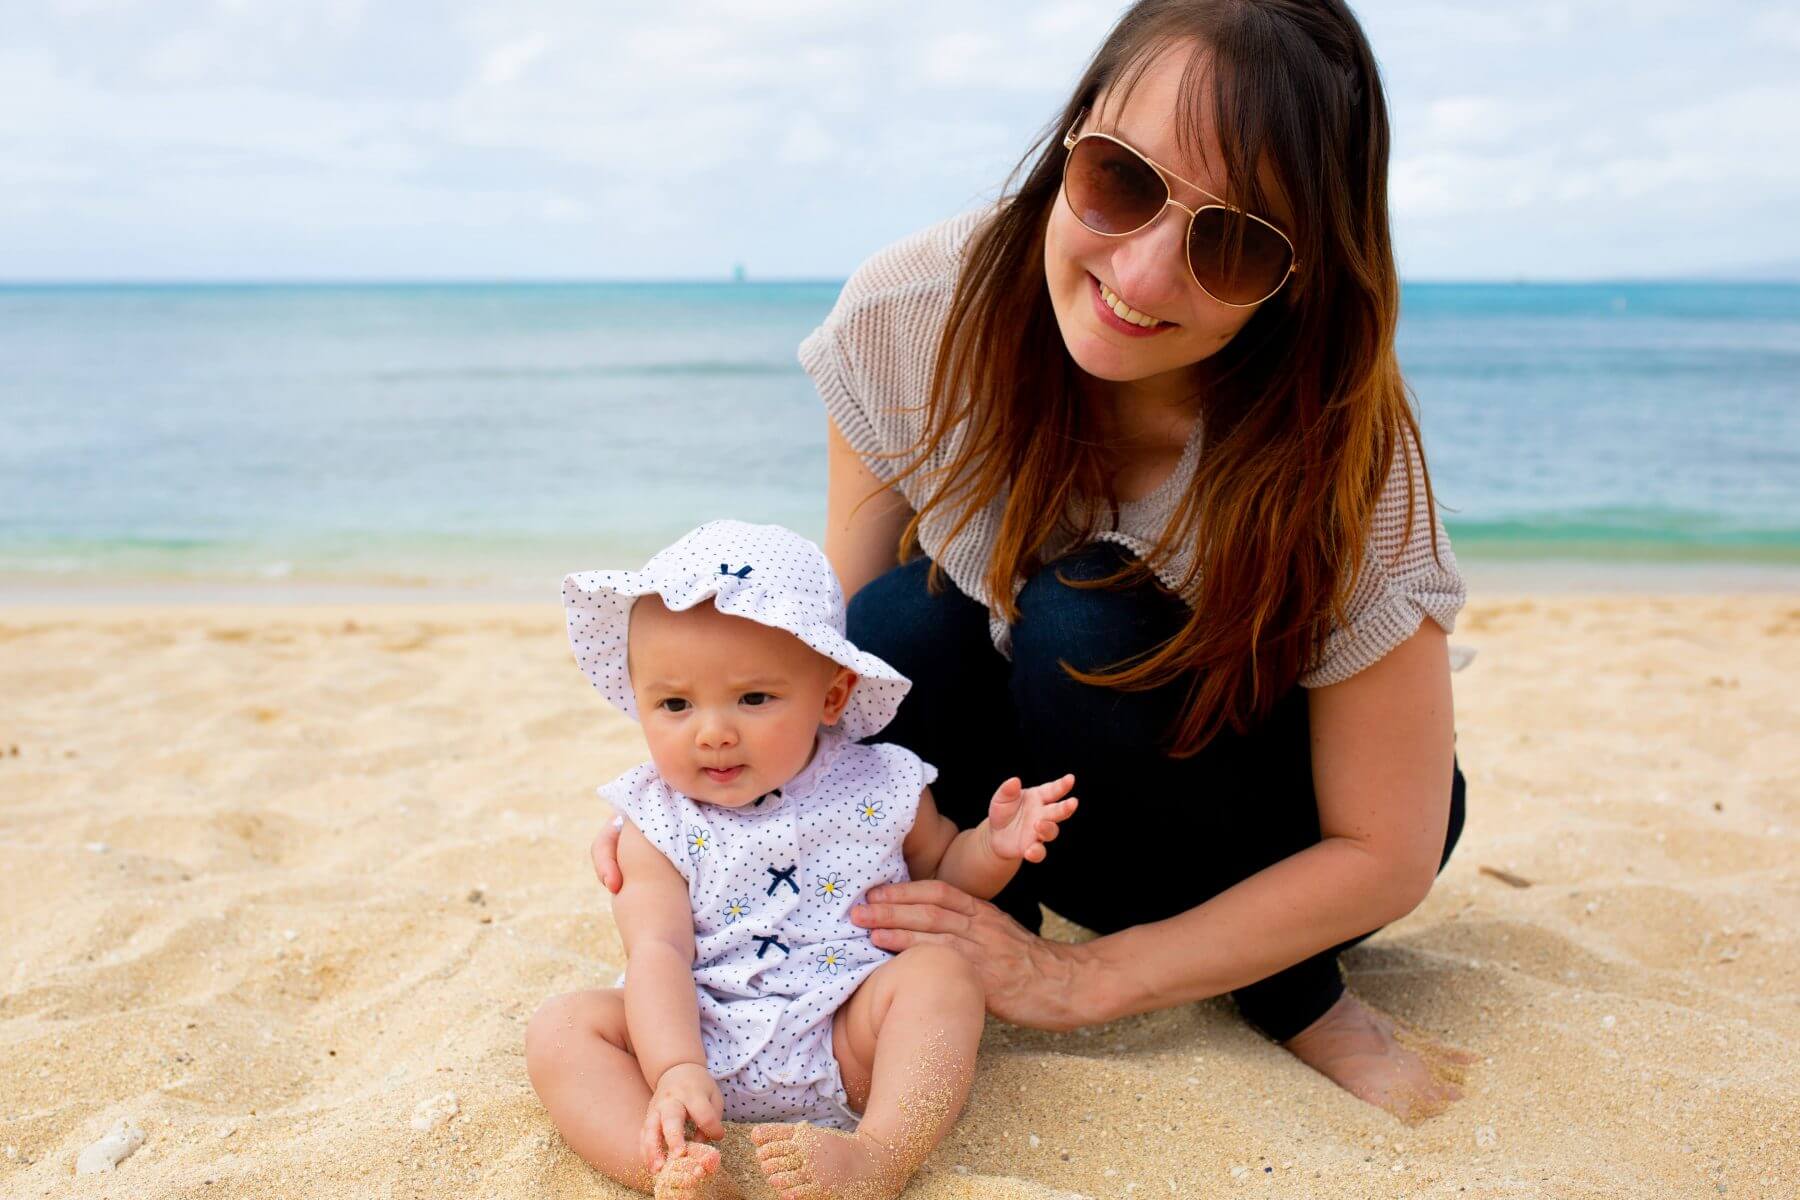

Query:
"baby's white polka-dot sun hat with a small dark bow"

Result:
[[563, 520, 913, 739]]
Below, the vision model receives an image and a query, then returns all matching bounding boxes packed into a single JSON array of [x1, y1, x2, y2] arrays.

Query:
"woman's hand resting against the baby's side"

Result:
[[850, 880, 1107, 1029]]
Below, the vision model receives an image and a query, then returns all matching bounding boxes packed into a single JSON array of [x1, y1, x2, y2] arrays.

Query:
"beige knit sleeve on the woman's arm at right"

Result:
[[1300, 430, 1467, 687]]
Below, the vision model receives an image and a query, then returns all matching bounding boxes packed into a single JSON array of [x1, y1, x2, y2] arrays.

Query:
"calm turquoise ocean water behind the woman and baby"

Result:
[[0, 282, 1800, 583]]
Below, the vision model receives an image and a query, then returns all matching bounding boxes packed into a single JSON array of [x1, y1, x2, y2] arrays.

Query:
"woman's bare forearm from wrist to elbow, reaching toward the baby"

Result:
[[1076, 838, 1429, 1022]]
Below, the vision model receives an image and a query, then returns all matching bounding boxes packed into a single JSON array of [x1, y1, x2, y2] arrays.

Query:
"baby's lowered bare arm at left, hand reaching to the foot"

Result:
[[612, 822, 725, 1171]]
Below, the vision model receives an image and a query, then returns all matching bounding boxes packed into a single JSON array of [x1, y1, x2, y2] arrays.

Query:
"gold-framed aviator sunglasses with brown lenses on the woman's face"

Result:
[[1062, 108, 1300, 308]]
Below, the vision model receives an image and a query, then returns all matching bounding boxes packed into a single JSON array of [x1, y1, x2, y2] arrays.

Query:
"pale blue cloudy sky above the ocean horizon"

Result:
[[0, 0, 1800, 281]]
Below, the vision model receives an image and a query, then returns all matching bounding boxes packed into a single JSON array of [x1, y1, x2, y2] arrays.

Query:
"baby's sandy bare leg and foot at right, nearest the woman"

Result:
[[751, 946, 986, 1200]]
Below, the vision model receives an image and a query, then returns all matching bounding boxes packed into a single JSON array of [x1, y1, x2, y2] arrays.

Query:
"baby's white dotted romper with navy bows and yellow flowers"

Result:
[[599, 727, 938, 1130]]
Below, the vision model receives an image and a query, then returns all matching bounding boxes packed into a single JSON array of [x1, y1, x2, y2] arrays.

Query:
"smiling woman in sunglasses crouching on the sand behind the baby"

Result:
[[596, 0, 1471, 1119]]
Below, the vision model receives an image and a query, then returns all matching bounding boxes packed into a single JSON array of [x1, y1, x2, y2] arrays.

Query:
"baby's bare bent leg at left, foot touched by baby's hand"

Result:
[[526, 988, 738, 1200]]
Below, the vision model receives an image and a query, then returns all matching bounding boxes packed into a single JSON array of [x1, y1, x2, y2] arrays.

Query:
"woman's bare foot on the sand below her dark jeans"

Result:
[[1282, 991, 1478, 1124]]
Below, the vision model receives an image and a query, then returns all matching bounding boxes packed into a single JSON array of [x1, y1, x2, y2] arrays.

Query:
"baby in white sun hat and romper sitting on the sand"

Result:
[[526, 522, 1076, 1200]]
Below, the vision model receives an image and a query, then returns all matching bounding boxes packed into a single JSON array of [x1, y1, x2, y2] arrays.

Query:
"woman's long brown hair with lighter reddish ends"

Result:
[[885, 0, 1436, 756]]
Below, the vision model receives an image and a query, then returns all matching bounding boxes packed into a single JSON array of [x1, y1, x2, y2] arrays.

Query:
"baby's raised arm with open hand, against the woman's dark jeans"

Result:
[[902, 775, 1076, 900]]
